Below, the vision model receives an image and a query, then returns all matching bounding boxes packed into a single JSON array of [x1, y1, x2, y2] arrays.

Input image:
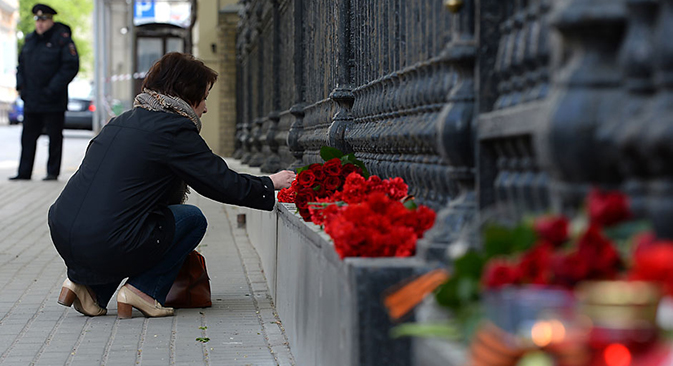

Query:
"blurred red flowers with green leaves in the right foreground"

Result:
[[437, 189, 644, 308]]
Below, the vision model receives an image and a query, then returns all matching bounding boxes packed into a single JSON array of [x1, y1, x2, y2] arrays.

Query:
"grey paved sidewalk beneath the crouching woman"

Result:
[[0, 125, 294, 366]]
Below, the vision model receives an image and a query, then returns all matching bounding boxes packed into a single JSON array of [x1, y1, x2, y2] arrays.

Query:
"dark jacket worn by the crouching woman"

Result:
[[49, 108, 275, 285]]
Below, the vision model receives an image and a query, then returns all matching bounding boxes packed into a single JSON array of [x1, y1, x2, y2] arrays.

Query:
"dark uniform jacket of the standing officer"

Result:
[[16, 22, 79, 113]]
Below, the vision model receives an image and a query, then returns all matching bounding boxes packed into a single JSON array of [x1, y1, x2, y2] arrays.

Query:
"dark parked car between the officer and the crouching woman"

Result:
[[64, 80, 96, 130]]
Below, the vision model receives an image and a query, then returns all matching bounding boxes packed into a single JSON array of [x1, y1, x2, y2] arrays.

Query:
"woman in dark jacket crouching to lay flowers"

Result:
[[48, 53, 295, 318]]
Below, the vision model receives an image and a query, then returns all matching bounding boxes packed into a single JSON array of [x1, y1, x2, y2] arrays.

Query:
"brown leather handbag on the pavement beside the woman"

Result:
[[165, 250, 213, 308]]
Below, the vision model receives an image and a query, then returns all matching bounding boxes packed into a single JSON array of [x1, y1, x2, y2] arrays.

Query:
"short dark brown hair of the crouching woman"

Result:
[[143, 52, 217, 106]]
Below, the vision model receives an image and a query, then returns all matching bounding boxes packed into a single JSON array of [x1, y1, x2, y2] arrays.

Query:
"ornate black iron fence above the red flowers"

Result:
[[236, 0, 673, 256]]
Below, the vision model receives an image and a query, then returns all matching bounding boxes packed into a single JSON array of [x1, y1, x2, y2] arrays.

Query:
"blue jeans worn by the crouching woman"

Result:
[[89, 205, 208, 308]]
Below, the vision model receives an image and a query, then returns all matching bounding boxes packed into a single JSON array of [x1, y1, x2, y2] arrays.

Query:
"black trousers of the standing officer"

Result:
[[19, 112, 65, 178]]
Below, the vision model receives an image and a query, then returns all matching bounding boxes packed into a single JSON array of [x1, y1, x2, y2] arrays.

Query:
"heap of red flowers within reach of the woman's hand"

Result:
[[278, 147, 435, 259]]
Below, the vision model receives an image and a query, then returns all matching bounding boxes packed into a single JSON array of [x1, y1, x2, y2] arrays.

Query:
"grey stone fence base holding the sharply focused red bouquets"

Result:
[[240, 203, 427, 366]]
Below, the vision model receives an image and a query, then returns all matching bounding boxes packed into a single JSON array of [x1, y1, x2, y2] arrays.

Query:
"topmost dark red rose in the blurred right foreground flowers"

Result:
[[587, 189, 631, 226]]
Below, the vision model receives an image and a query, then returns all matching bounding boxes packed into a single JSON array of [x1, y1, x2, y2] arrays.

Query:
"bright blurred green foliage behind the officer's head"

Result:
[[17, 0, 94, 79]]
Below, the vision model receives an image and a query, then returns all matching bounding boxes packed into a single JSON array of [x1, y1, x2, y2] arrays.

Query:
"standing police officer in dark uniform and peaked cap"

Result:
[[9, 4, 79, 180]]
